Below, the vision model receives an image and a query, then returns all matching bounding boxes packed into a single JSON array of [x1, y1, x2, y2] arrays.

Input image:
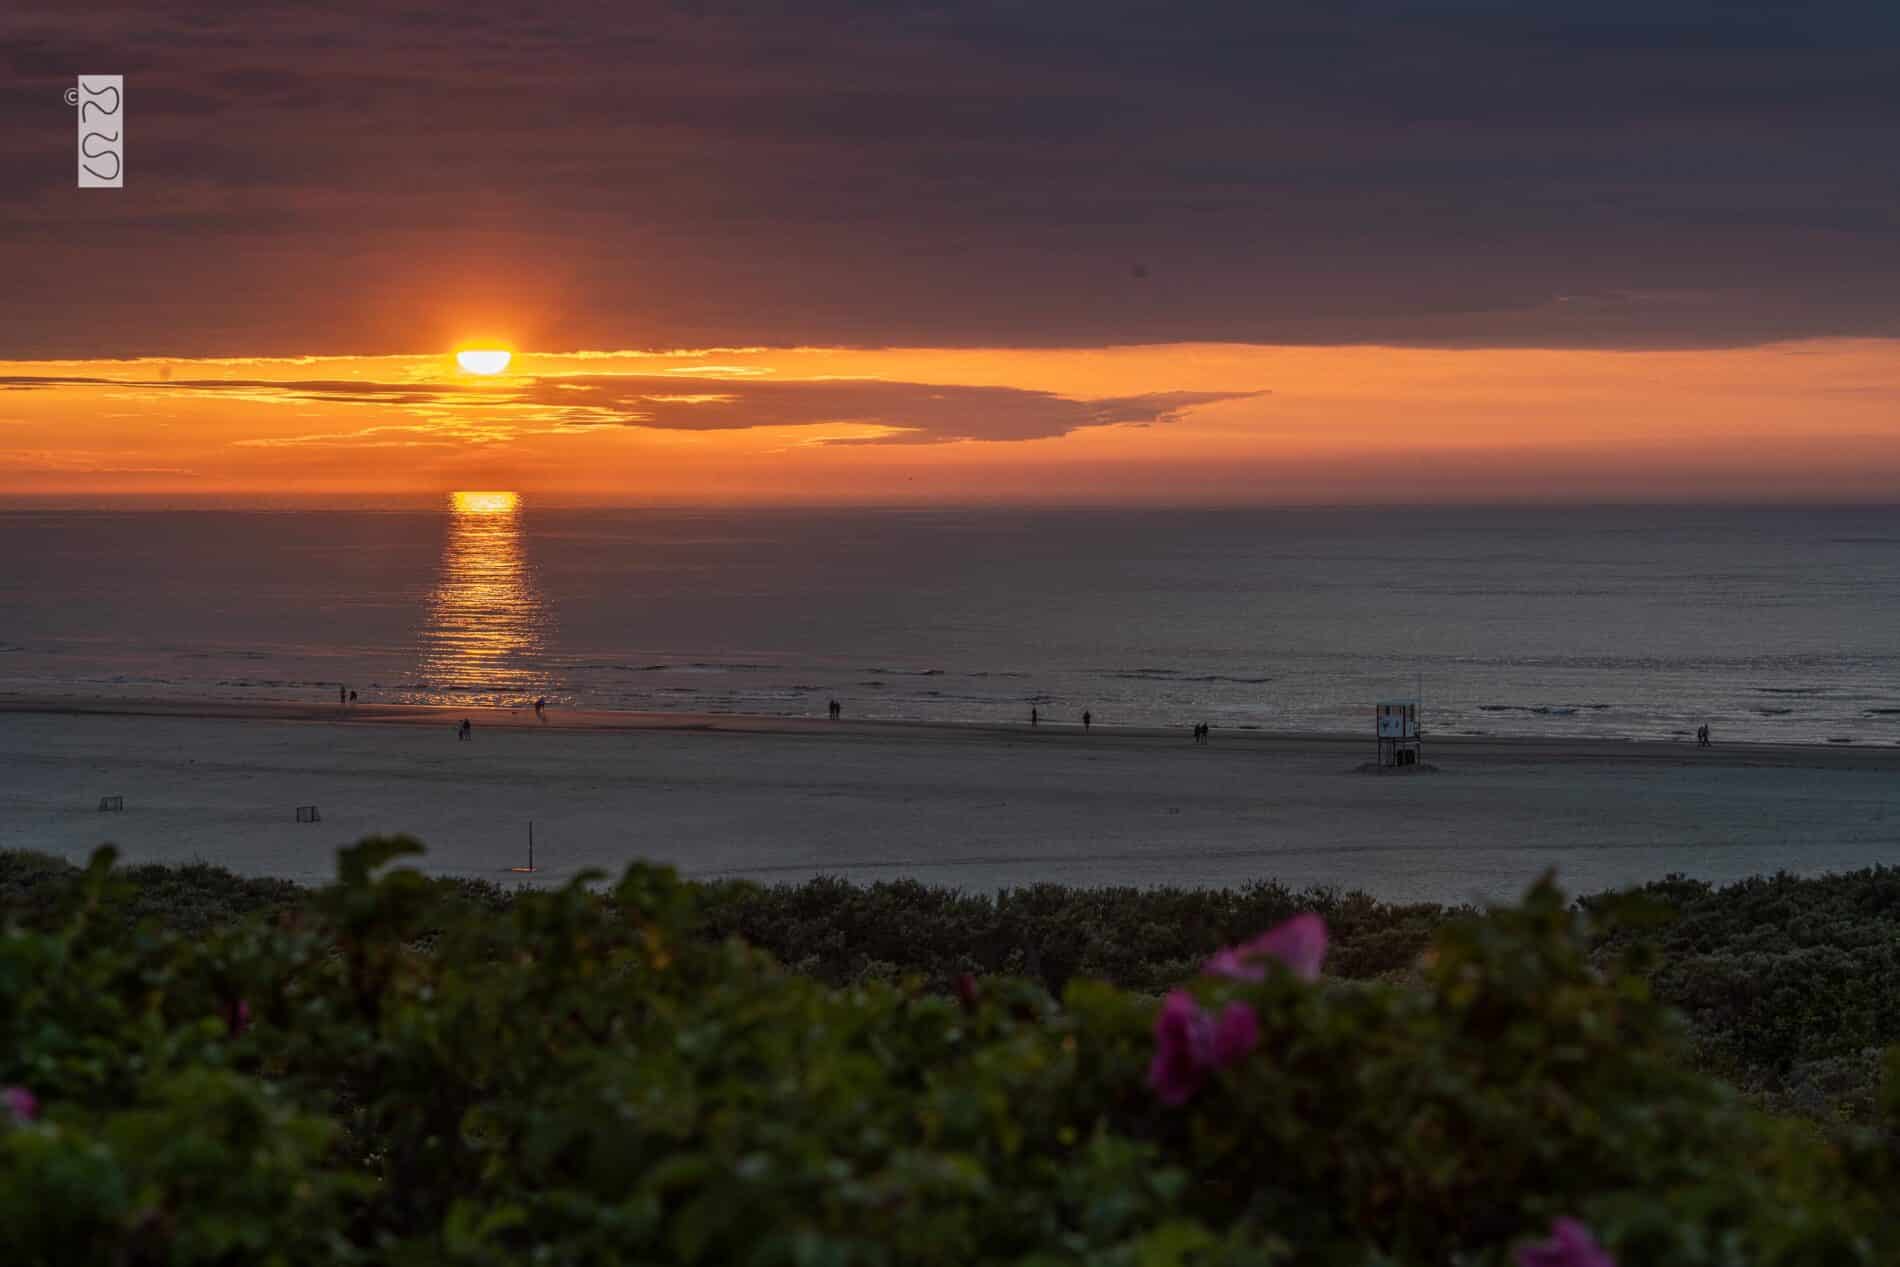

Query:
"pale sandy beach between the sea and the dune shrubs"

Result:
[[0, 697, 1900, 900]]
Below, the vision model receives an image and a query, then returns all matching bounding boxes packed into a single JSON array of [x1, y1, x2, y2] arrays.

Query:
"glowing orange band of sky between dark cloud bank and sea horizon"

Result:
[[11, 340, 1900, 503]]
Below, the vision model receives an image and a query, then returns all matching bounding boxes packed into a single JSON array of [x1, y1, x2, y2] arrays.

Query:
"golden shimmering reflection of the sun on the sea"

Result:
[[422, 490, 547, 703]]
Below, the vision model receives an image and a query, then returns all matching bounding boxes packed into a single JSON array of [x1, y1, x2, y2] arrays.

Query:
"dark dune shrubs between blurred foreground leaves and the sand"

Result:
[[0, 851, 1900, 1123]]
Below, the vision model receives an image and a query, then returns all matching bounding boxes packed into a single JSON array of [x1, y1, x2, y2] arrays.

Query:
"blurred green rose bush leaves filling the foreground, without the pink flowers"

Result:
[[0, 840, 1900, 1267]]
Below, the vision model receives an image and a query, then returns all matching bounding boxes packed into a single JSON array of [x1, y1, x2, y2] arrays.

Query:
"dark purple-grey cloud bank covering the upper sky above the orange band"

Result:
[[0, 0, 1900, 357]]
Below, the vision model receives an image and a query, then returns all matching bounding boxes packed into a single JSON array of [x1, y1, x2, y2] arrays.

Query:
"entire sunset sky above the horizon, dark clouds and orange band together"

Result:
[[0, 0, 1900, 503]]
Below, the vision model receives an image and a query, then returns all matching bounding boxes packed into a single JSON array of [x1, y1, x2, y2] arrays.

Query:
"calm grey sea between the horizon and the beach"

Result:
[[0, 494, 1900, 745]]
